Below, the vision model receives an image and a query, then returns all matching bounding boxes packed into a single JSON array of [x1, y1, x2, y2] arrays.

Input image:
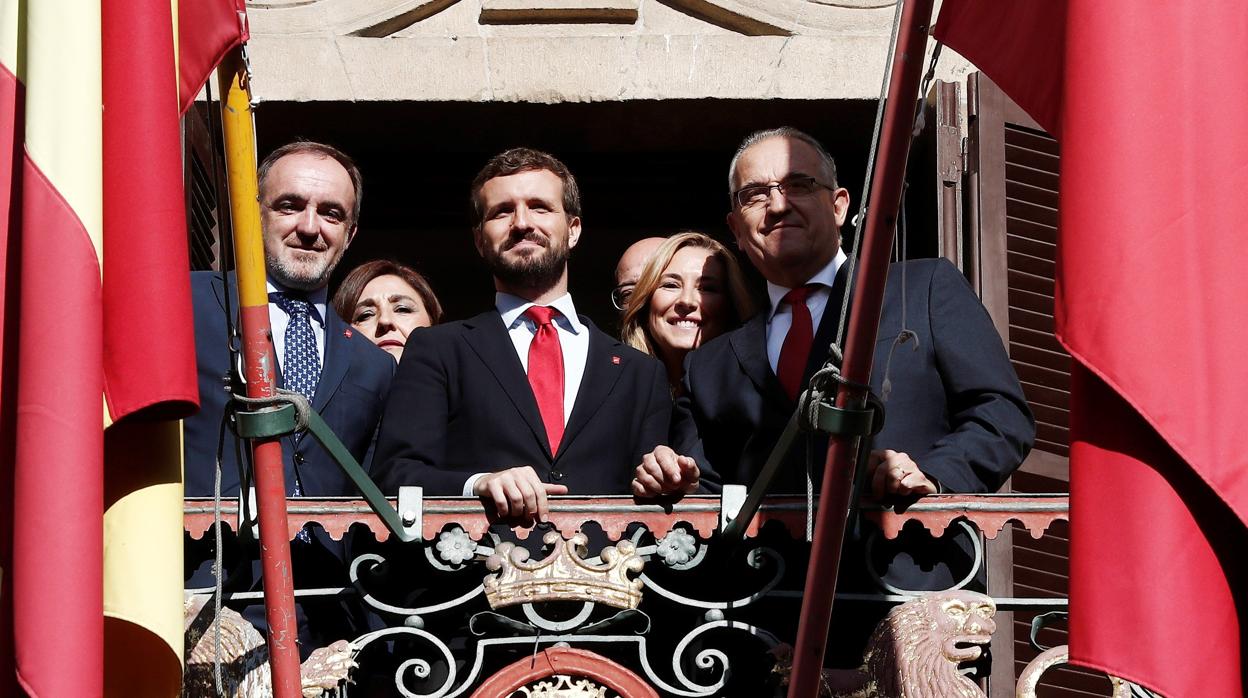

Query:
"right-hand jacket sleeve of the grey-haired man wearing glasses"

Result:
[[915, 260, 1036, 492]]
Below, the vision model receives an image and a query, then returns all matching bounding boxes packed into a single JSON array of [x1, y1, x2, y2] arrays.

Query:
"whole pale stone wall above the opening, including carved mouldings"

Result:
[[248, 0, 970, 104]]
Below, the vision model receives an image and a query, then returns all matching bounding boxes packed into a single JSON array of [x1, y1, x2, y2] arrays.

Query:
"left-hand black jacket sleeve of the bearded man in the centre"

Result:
[[373, 331, 466, 496]]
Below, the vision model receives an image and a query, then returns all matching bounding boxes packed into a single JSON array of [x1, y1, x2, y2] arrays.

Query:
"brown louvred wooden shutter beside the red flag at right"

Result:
[[958, 74, 1109, 696]]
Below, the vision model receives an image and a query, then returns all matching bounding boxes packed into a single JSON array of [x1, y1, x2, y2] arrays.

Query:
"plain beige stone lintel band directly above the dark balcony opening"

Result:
[[248, 35, 968, 104]]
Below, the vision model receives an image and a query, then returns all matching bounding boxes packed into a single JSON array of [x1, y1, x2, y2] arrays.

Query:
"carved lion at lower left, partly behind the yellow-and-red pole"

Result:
[[182, 594, 356, 698]]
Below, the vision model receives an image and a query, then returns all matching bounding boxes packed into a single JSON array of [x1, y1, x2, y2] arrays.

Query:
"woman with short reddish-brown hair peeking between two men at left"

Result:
[[333, 260, 442, 361]]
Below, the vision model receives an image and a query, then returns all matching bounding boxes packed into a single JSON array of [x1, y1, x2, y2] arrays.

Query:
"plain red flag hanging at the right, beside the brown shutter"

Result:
[[937, 0, 1248, 697]]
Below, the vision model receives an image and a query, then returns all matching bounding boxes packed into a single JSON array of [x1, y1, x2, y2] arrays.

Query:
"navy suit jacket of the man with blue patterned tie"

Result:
[[185, 272, 394, 658]]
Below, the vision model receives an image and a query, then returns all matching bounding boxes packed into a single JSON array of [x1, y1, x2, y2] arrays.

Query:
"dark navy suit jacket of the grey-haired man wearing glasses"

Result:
[[671, 260, 1035, 493]]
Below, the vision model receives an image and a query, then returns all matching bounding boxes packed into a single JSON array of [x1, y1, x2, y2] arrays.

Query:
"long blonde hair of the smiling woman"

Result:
[[620, 230, 754, 356]]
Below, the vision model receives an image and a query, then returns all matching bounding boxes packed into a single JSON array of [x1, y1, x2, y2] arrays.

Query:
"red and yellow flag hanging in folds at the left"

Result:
[[0, 0, 245, 697]]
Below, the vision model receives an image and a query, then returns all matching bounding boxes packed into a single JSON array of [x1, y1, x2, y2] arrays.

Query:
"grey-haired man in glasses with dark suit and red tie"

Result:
[[634, 127, 1035, 663]]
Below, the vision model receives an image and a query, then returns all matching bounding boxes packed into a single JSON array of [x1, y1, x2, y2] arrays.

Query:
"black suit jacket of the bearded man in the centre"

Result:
[[376, 310, 671, 496]]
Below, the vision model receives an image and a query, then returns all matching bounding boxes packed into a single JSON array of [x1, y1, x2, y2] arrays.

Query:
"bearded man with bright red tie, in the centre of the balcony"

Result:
[[377, 149, 671, 522]]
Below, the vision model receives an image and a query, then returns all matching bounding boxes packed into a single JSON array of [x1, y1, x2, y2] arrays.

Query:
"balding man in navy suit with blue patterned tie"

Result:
[[185, 141, 394, 654]]
